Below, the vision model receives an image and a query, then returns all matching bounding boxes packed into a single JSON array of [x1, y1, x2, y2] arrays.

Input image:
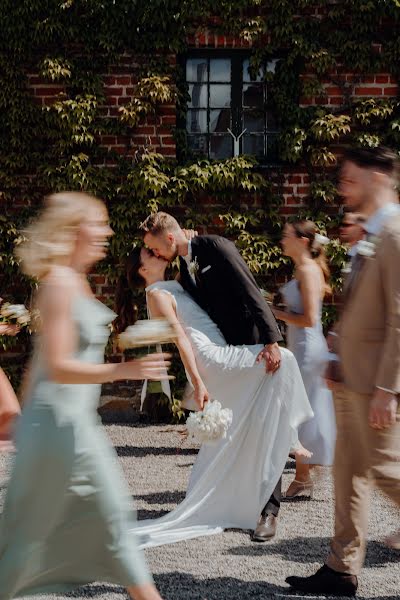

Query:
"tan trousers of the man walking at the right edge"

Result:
[[326, 388, 400, 575]]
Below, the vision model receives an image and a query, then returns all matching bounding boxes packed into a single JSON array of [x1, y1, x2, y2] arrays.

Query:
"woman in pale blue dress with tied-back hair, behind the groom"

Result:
[[273, 221, 336, 499]]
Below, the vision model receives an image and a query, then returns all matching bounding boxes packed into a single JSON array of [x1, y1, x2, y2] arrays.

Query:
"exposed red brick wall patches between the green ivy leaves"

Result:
[[4, 30, 398, 404]]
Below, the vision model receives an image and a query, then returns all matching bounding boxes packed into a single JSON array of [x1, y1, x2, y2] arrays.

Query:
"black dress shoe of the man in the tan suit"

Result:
[[286, 565, 358, 596]]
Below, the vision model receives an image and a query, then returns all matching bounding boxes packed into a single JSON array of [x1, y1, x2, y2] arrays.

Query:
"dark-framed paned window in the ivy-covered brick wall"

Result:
[[186, 51, 278, 162]]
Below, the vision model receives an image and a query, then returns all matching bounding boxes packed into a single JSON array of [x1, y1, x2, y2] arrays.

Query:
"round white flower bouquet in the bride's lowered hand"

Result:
[[186, 400, 232, 444]]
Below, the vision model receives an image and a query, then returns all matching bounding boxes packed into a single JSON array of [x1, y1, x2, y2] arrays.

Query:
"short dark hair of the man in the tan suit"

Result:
[[342, 146, 400, 182]]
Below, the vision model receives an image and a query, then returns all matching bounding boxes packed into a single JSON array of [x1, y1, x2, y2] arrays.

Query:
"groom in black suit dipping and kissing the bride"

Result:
[[141, 212, 282, 542]]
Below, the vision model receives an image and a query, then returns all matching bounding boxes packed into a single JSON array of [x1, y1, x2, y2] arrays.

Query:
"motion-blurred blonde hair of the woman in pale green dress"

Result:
[[15, 192, 105, 280]]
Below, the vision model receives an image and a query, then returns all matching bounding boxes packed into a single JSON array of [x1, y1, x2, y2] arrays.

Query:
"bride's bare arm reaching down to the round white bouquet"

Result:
[[147, 290, 209, 409]]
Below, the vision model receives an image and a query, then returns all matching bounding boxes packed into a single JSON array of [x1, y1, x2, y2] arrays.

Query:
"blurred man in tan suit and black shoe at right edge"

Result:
[[286, 148, 400, 596]]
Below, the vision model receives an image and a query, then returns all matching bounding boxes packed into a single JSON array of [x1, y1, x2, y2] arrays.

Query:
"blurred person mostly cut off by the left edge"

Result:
[[0, 323, 21, 451]]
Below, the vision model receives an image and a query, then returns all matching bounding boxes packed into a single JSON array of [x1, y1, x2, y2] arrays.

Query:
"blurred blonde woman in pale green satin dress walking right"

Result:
[[0, 192, 169, 600]]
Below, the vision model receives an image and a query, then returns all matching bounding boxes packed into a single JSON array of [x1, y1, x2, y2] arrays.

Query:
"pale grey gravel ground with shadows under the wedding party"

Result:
[[0, 423, 400, 600]]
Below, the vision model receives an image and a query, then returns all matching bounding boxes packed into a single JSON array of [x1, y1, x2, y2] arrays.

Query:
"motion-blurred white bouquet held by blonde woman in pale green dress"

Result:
[[118, 319, 176, 350]]
